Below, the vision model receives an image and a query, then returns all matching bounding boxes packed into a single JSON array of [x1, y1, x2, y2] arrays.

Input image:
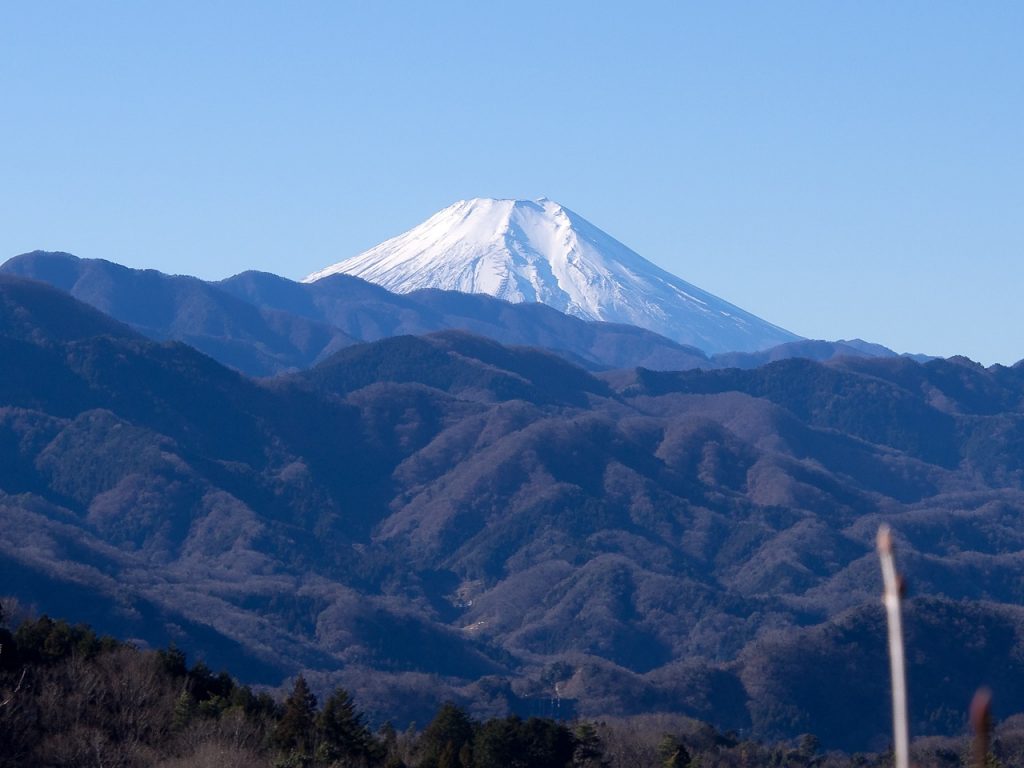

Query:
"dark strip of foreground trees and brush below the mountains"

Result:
[[0, 601, 1024, 768]]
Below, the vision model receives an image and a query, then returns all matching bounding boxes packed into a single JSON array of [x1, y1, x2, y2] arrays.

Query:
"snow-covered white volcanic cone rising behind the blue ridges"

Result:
[[303, 198, 800, 352]]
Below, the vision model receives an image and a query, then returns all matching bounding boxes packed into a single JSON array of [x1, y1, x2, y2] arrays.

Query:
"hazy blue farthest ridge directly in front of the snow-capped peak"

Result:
[[0, 251, 913, 377]]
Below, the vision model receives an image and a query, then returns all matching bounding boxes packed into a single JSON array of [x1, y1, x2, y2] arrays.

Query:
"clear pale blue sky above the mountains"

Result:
[[0, 0, 1024, 364]]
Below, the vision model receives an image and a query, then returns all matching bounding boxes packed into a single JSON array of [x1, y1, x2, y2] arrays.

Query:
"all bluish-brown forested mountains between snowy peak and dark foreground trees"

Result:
[[0, 264, 1024, 760]]
